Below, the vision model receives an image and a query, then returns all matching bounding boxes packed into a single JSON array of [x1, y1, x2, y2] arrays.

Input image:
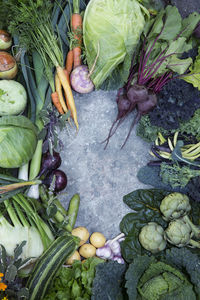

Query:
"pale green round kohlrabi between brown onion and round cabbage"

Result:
[[0, 80, 27, 116]]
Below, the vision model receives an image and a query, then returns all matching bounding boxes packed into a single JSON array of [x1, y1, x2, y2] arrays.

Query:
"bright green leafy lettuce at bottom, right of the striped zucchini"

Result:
[[44, 257, 104, 300]]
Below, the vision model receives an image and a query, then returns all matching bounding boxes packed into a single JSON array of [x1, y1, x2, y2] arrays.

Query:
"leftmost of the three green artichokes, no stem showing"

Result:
[[139, 222, 167, 253]]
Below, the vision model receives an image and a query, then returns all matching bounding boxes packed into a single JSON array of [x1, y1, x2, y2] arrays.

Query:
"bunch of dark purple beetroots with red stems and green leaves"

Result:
[[104, 5, 200, 148]]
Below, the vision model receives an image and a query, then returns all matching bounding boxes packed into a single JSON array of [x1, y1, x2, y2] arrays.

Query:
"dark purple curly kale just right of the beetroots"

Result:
[[149, 79, 200, 130]]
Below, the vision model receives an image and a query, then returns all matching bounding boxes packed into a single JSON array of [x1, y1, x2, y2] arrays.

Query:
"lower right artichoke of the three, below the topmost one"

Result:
[[165, 219, 200, 248]]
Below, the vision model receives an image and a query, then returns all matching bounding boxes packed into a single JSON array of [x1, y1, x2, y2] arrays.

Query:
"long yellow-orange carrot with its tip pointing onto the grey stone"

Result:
[[56, 66, 79, 130]]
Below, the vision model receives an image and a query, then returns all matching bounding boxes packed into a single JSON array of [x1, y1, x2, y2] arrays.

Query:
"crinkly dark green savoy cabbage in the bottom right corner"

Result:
[[125, 256, 196, 300]]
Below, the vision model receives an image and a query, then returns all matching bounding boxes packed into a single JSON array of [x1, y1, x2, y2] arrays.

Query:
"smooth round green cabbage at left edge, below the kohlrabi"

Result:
[[0, 116, 37, 168]]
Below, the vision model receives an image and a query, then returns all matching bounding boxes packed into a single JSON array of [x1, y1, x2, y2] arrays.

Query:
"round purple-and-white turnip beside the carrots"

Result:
[[70, 65, 94, 94]]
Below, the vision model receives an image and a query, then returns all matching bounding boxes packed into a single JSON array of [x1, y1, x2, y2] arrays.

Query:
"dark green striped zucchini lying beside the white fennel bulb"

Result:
[[27, 234, 80, 300]]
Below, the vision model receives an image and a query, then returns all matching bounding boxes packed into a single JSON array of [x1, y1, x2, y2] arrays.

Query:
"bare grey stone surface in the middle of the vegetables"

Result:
[[60, 91, 150, 238]]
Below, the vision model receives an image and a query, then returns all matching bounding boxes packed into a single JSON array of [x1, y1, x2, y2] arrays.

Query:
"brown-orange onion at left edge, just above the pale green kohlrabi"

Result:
[[0, 51, 18, 79]]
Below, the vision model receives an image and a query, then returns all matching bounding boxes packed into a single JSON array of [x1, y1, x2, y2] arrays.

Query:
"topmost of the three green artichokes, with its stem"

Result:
[[160, 192, 200, 238]]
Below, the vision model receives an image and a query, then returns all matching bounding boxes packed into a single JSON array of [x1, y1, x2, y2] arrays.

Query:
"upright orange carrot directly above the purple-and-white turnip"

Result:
[[71, 0, 83, 68]]
